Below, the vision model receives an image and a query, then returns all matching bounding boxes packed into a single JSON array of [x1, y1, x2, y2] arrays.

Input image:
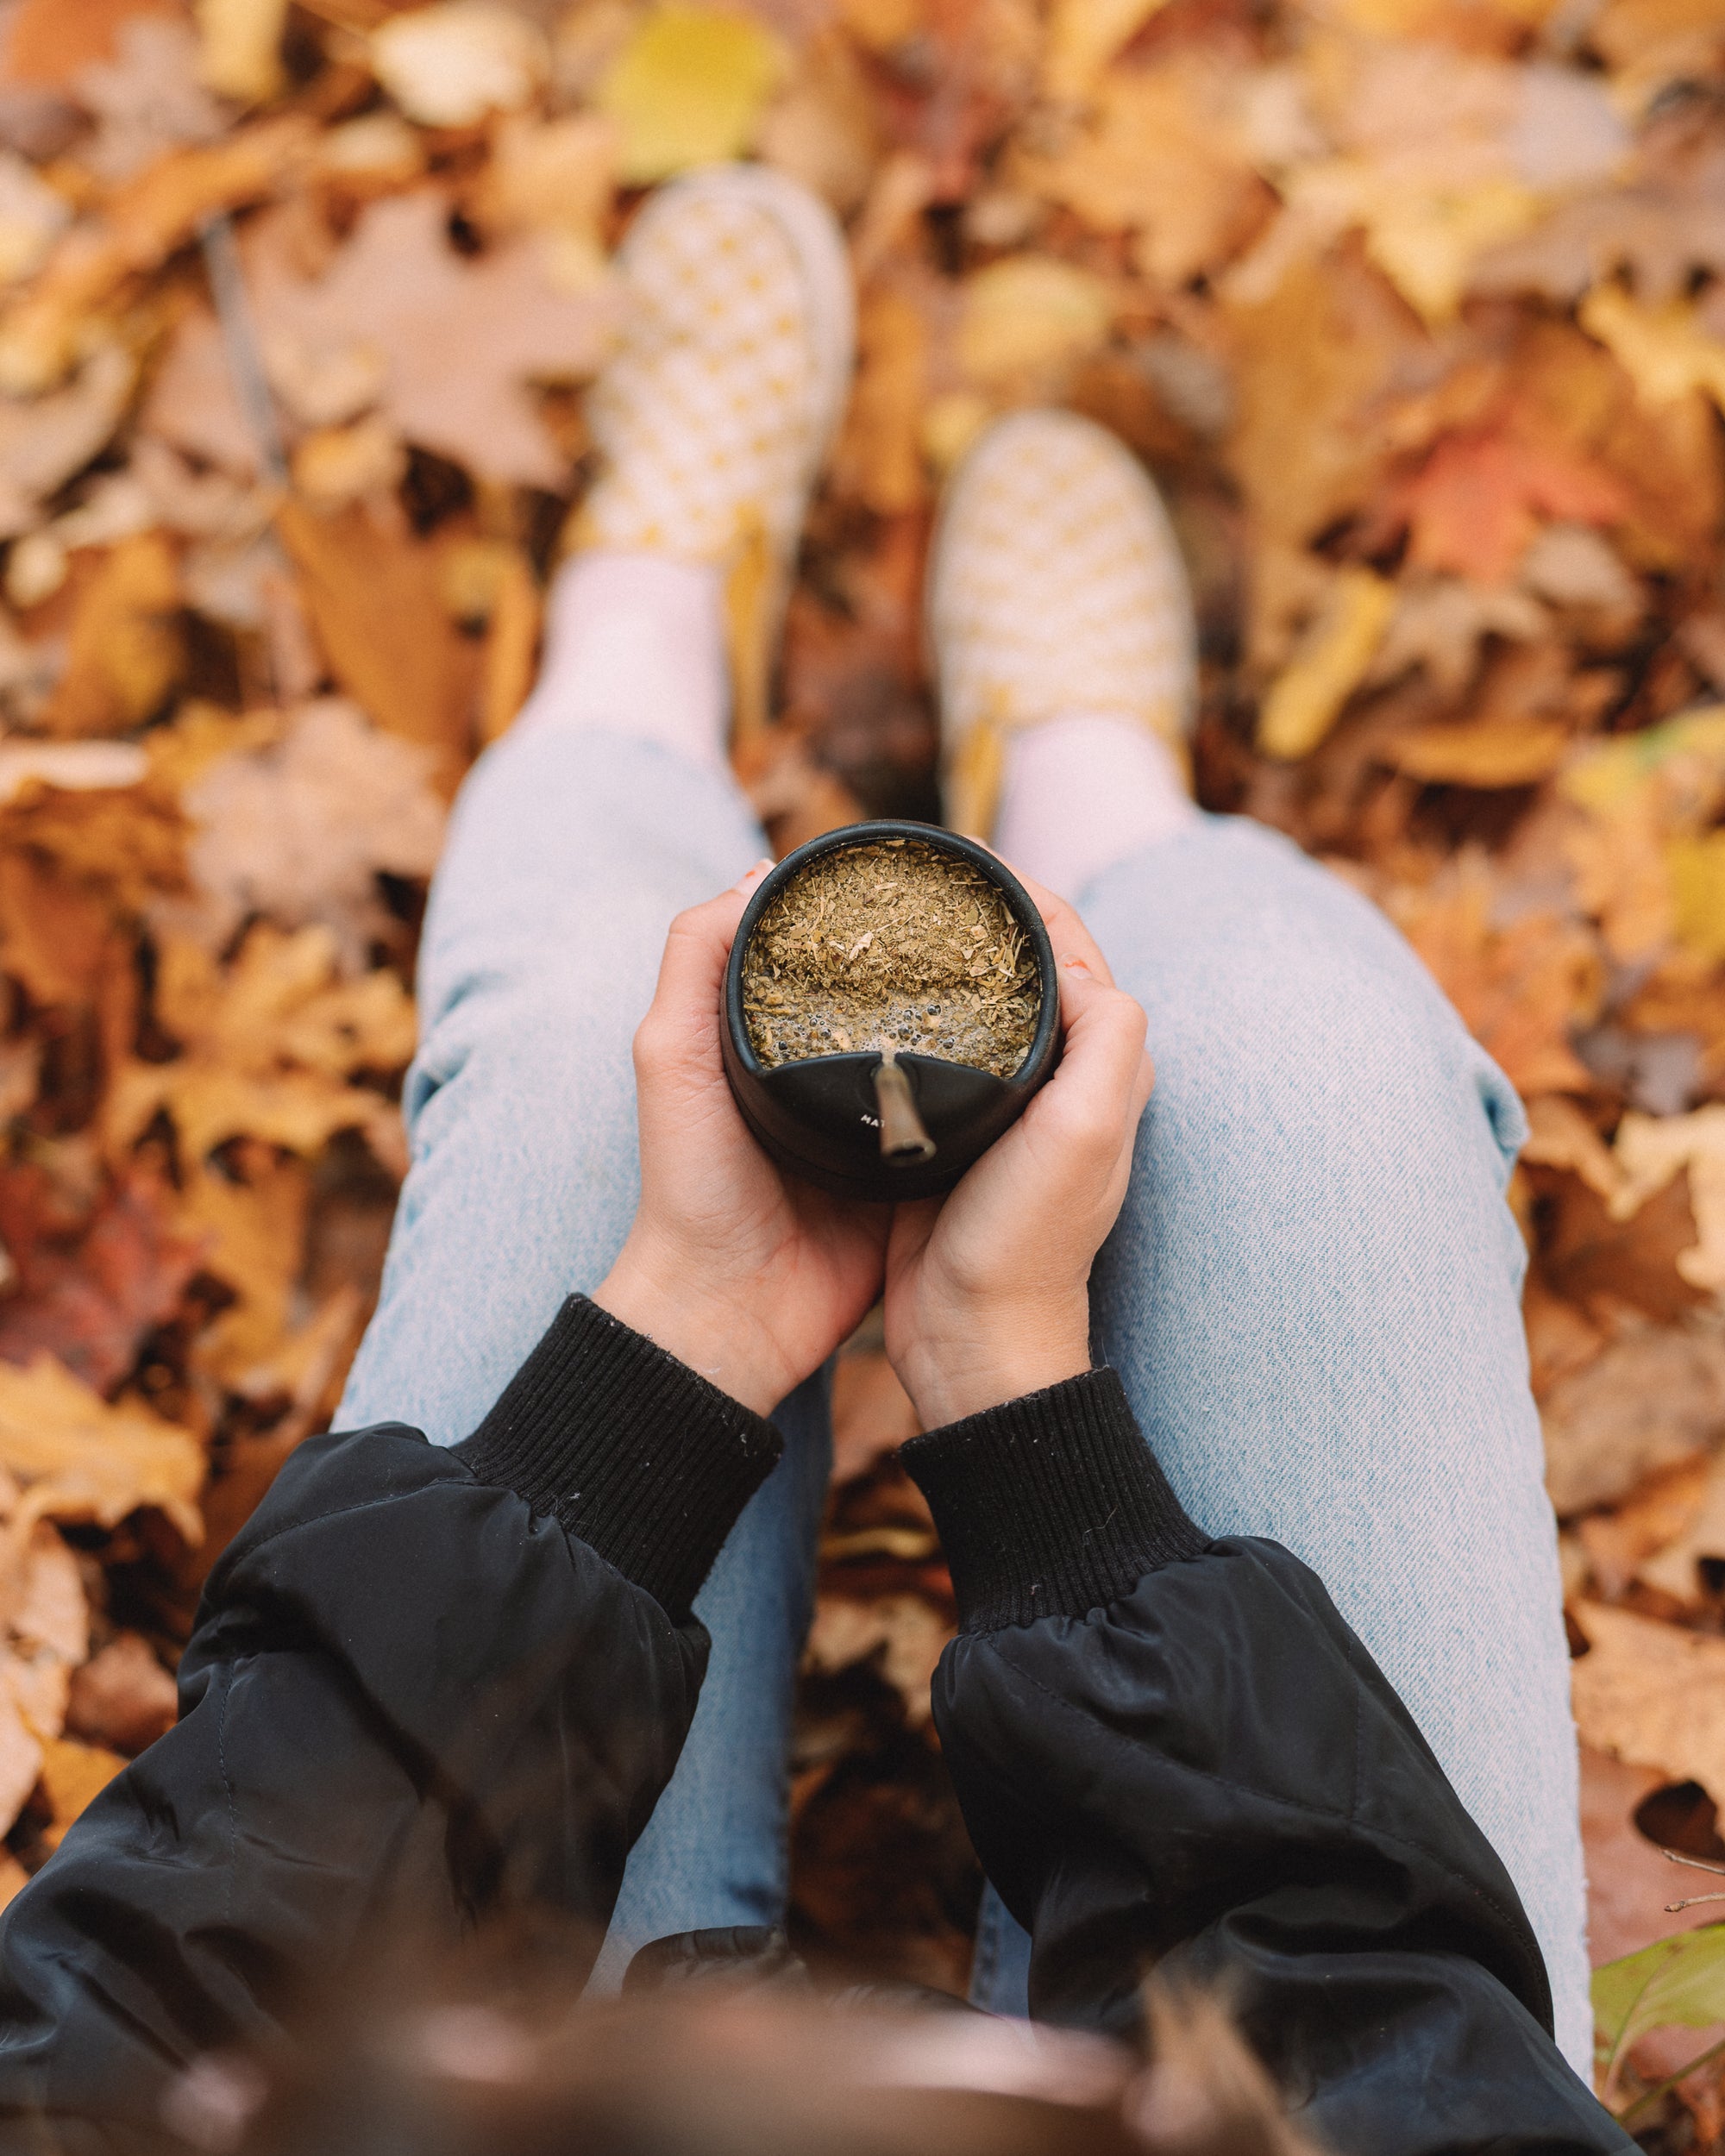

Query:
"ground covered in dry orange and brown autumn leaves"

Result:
[[0, 0, 1725, 2147]]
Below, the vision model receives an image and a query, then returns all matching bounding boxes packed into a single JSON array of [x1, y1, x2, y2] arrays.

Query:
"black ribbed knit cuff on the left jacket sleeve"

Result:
[[455, 1296, 785, 1620]]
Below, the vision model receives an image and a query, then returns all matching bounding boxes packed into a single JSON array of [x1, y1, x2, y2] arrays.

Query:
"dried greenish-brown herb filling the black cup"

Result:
[[742, 839, 1042, 1078]]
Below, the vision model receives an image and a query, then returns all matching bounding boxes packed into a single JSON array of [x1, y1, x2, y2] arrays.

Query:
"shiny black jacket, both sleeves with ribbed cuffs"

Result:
[[0, 1298, 1633, 2156]]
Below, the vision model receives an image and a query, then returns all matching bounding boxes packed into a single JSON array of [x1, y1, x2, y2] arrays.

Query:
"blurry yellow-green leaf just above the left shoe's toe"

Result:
[[595, 0, 789, 185]]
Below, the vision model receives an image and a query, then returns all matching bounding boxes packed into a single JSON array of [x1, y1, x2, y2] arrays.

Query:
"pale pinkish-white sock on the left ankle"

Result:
[[518, 552, 731, 770]]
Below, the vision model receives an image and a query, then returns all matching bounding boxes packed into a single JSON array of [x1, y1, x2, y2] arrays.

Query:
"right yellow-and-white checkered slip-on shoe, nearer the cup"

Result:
[[927, 412, 1197, 839]]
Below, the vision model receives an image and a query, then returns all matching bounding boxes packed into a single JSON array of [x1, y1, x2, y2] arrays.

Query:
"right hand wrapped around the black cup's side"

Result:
[[887, 884, 1156, 1430]]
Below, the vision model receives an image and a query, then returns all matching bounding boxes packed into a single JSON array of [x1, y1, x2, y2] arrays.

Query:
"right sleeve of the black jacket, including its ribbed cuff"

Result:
[[904, 1369, 1633, 2156]]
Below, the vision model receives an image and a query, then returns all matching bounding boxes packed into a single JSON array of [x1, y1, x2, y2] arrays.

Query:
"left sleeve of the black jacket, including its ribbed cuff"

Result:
[[0, 1300, 779, 2150]]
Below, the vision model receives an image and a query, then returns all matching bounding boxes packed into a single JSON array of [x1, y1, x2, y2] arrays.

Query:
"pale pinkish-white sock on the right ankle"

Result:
[[994, 711, 1197, 897]]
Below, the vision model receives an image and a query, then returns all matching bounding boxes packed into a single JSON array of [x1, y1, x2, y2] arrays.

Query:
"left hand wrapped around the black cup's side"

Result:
[[593, 862, 888, 1414]]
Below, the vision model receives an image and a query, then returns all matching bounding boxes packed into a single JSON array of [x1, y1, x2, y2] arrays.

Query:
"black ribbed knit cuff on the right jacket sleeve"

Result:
[[900, 1369, 1210, 1633]]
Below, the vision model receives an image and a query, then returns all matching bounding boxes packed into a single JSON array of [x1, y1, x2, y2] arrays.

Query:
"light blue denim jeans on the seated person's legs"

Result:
[[341, 716, 1590, 2072]]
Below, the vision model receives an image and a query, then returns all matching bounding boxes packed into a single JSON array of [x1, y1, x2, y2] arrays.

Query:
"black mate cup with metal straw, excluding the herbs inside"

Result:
[[718, 822, 1061, 1203]]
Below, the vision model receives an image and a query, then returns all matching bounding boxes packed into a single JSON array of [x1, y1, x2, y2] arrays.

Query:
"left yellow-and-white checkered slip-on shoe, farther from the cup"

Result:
[[576, 164, 856, 753]]
